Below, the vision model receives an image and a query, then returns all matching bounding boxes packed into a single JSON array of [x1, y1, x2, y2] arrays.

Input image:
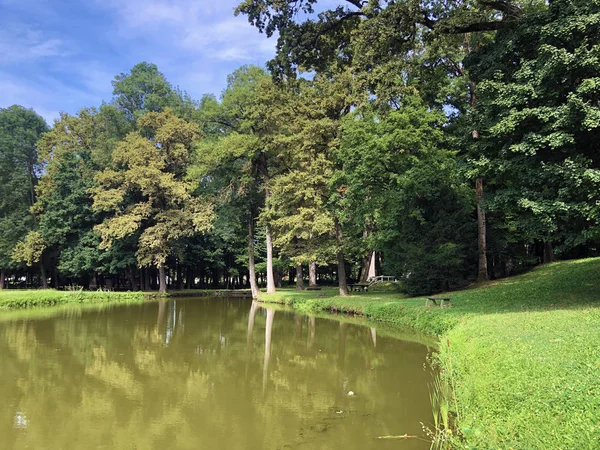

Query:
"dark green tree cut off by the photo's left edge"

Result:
[[0, 105, 48, 289]]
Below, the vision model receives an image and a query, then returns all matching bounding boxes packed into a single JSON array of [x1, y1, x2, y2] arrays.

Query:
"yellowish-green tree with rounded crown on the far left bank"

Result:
[[92, 109, 213, 292]]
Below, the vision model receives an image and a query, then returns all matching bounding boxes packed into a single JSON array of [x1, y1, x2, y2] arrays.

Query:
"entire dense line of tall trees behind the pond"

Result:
[[0, 0, 600, 295]]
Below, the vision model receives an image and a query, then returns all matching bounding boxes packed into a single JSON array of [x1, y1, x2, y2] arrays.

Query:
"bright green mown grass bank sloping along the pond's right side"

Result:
[[261, 258, 600, 449]]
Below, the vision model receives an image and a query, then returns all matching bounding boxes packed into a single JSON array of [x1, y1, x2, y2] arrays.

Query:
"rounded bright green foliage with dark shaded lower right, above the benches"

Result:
[[337, 98, 475, 295]]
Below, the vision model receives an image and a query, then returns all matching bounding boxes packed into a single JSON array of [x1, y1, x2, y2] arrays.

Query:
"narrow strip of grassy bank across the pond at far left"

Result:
[[0, 289, 144, 311]]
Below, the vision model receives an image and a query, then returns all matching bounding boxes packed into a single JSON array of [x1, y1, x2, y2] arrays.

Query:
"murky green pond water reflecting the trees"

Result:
[[0, 299, 431, 450]]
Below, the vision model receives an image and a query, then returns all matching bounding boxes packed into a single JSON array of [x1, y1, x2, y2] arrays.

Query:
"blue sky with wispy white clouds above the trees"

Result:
[[0, 0, 275, 124]]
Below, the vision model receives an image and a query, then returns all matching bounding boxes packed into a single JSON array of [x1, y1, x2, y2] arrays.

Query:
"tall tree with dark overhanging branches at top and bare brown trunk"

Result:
[[236, 0, 545, 279]]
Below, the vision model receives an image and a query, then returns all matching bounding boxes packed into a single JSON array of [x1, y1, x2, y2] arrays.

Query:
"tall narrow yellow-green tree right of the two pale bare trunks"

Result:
[[262, 73, 352, 295]]
